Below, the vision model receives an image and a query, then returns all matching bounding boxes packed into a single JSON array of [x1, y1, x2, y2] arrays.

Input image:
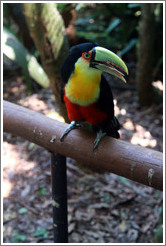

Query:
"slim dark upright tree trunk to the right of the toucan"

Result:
[[137, 3, 155, 106]]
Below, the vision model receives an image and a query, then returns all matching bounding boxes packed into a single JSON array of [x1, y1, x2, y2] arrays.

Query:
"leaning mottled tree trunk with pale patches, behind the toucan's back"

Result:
[[22, 3, 68, 121]]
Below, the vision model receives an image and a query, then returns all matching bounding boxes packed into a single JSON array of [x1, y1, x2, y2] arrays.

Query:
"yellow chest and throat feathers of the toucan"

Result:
[[65, 58, 101, 106]]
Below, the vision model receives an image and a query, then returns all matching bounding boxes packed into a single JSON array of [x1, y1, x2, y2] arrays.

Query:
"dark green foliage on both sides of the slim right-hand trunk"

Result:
[[58, 3, 163, 70]]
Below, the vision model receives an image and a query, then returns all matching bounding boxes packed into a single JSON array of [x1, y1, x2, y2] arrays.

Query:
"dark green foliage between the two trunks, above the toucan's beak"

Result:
[[73, 3, 141, 52]]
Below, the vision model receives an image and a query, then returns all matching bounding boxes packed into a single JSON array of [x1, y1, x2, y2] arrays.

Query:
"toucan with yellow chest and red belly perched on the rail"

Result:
[[60, 42, 128, 149]]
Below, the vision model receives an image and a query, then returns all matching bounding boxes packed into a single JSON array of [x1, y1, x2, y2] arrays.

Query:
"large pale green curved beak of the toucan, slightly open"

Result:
[[90, 46, 128, 83]]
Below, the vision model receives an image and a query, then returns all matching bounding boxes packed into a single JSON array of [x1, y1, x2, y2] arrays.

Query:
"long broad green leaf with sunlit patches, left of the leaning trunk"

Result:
[[3, 4, 50, 94]]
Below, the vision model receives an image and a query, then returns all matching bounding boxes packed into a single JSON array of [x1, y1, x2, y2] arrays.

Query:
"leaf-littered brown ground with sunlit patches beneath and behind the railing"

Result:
[[3, 71, 163, 243]]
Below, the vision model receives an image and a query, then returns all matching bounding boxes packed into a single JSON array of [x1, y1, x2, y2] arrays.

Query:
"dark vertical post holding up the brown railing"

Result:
[[51, 153, 68, 243]]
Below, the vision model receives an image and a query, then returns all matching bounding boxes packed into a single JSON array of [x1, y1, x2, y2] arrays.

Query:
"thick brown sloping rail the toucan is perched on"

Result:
[[3, 101, 163, 190]]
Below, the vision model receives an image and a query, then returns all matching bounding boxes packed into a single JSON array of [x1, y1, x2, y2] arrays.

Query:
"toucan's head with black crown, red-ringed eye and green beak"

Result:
[[61, 43, 128, 82]]
